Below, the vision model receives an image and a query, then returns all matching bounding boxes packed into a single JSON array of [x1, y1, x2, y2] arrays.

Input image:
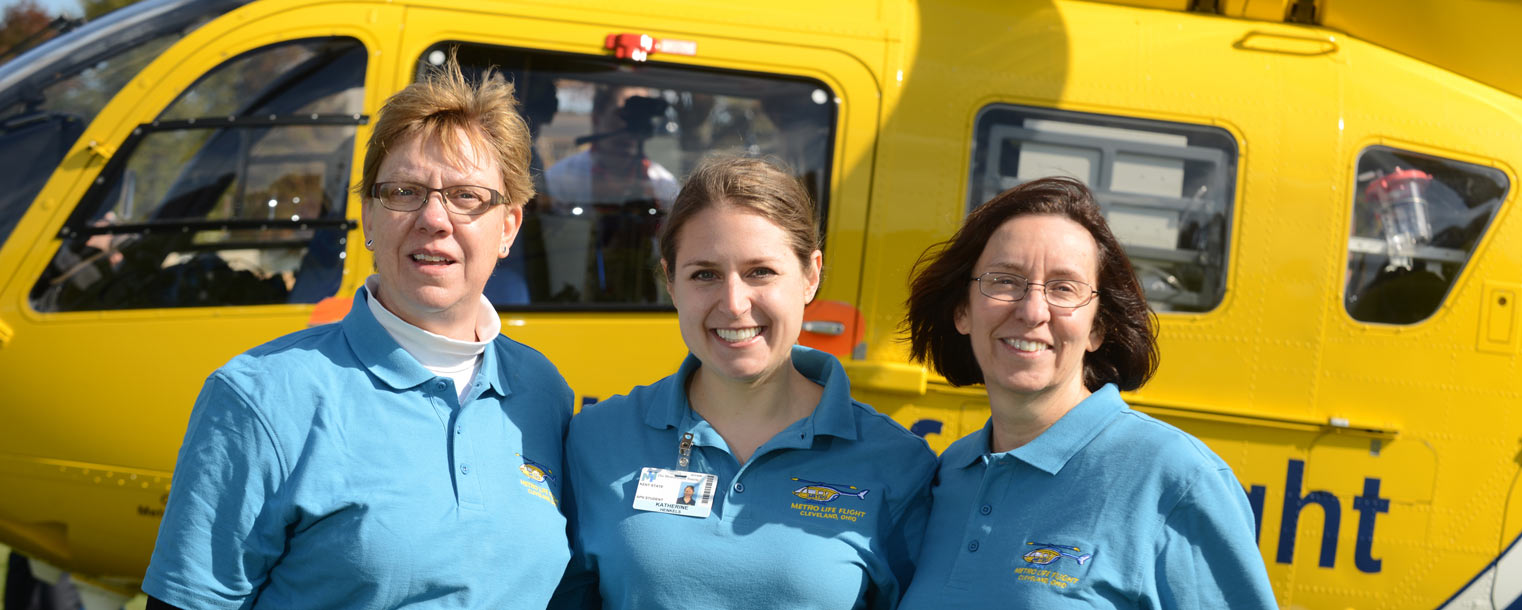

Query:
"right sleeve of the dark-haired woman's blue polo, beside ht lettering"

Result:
[[1155, 469, 1278, 610]]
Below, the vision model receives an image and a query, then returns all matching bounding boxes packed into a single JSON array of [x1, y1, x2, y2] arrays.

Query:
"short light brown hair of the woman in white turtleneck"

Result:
[[355, 50, 534, 205]]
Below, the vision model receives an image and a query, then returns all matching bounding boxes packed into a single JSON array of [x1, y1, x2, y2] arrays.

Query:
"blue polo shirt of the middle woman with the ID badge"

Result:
[[551, 347, 936, 610]]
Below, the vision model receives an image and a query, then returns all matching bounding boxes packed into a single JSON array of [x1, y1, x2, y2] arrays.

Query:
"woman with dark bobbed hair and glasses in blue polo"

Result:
[[903, 178, 1275, 608]]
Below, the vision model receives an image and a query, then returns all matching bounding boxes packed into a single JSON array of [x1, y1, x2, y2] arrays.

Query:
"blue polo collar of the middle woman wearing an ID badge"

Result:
[[645, 345, 858, 447]]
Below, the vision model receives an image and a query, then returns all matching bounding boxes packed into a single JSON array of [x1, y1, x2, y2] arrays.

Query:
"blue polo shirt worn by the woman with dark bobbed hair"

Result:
[[904, 385, 1278, 610]]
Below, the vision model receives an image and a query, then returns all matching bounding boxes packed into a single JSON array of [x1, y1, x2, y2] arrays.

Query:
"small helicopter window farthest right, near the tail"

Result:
[[1342, 146, 1510, 324]]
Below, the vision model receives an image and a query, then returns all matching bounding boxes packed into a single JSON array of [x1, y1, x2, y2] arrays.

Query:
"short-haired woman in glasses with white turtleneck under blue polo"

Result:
[[143, 58, 572, 608]]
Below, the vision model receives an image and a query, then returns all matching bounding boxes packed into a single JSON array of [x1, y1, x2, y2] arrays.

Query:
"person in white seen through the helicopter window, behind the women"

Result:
[[545, 85, 679, 214]]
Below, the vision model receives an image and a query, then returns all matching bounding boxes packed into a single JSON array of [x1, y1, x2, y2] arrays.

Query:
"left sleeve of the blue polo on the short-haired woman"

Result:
[[143, 374, 288, 608]]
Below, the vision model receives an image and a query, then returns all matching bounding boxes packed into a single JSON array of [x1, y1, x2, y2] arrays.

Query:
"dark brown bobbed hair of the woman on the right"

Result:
[[904, 178, 1158, 391]]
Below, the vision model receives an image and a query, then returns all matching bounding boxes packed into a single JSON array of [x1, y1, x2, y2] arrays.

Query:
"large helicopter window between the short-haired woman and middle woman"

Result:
[[435, 43, 836, 310]]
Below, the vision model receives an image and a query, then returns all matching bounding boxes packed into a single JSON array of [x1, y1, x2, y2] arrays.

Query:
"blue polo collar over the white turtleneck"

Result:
[[341, 286, 508, 396]]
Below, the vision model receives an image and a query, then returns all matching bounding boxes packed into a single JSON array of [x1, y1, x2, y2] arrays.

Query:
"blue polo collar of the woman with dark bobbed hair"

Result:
[[944, 383, 1126, 475]]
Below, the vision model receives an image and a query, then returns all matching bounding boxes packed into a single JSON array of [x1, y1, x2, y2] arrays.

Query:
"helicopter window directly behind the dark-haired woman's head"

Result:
[[966, 105, 1236, 312]]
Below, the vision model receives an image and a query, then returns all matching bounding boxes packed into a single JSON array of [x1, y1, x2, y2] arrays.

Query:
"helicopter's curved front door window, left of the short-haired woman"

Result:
[[32, 38, 367, 312]]
